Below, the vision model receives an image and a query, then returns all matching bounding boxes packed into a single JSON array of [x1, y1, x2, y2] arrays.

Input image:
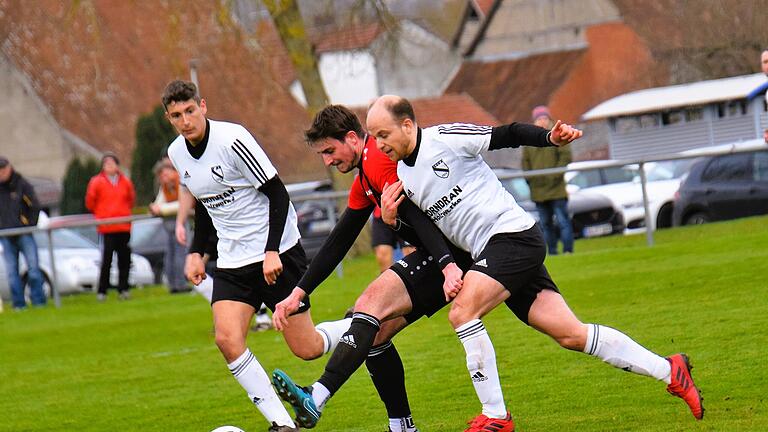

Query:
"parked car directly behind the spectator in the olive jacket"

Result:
[[494, 168, 624, 238]]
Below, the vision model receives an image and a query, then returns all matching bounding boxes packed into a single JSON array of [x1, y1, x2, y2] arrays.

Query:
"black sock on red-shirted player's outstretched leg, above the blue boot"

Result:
[[318, 312, 381, 394]]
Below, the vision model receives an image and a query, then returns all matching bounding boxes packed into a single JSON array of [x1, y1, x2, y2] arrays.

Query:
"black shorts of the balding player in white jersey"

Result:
[[470, 223, 560, 324]]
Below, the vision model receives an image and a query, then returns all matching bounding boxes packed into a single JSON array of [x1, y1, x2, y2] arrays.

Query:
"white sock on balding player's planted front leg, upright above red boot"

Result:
[[456, 319, 507, 418]]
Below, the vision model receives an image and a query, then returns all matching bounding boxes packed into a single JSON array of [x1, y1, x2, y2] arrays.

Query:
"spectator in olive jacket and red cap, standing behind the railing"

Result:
[[523, 105, 573, 255]]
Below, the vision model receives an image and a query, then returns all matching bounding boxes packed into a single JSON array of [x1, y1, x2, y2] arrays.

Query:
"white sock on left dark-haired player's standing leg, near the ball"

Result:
[[227, 348, 296, 427]]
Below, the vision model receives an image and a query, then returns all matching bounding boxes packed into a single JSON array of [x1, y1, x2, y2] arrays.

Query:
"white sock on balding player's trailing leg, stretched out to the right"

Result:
[[584, 324, 672, 384]]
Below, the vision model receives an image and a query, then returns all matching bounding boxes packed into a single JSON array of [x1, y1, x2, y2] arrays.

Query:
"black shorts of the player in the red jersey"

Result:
[[390, 248, 472, 324]]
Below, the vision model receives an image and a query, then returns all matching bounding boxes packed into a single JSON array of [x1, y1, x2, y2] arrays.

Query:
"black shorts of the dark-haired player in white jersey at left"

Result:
[[211, 243, 309, 313]]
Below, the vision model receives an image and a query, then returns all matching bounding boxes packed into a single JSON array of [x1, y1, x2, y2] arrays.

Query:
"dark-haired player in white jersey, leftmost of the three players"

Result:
[[163, 81, 351, 432]]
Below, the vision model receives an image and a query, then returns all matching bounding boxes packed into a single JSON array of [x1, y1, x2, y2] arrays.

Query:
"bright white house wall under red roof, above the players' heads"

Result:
[[318, 51, 380, 105]]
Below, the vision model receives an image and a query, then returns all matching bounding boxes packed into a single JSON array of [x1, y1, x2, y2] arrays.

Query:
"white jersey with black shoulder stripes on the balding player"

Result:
[[397, 123, 546, 258]]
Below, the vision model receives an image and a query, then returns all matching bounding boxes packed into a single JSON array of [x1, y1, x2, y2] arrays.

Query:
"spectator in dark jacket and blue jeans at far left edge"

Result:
[[0, 156, 45, 310]]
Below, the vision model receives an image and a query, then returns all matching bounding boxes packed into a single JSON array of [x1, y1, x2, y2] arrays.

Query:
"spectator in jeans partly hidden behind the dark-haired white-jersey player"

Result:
[[149, 160, 191, 294]]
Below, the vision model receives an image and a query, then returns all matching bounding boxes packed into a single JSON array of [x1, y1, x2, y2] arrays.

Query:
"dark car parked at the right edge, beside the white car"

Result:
[[672, 150, 768, 225]]
